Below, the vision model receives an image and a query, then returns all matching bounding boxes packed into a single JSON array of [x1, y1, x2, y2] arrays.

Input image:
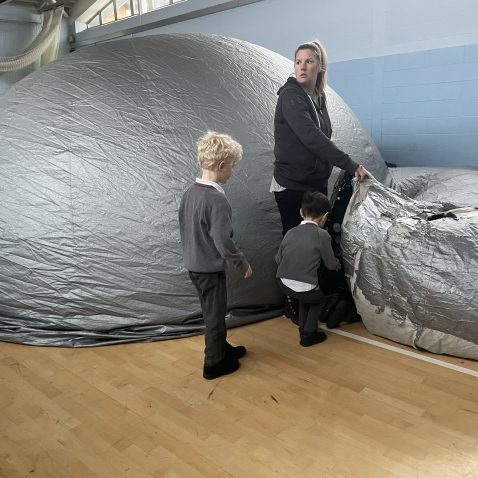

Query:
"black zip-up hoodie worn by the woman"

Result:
[[274, 77, 358, 191]]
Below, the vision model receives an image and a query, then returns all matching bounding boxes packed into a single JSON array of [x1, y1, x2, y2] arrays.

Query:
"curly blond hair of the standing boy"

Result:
[[197, 131, 242, 170]]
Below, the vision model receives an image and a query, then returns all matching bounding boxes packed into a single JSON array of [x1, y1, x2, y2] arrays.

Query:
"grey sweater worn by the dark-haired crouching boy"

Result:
[[276, 223, 340, 284]]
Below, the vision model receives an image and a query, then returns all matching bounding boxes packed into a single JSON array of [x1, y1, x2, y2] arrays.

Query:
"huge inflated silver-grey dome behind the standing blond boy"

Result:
[[0, 34, 391, 346]]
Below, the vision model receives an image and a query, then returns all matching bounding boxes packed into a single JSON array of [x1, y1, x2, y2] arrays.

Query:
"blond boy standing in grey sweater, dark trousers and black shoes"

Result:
[[179, 131, 252, 380]]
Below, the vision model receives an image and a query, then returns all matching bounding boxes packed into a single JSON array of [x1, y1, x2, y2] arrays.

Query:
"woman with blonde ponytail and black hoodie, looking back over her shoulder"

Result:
[[271, 41, 367, 235]]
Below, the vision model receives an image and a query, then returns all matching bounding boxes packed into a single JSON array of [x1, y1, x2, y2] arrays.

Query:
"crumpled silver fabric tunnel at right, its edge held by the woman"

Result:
[[342, 176, 478, 360]]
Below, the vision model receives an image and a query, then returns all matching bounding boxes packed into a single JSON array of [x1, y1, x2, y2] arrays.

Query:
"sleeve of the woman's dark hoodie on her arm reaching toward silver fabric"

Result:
[[282, 88, 359, 174]]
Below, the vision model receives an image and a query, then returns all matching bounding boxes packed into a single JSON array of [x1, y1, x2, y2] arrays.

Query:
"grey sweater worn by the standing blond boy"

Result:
[[179, 183, 249, 272]]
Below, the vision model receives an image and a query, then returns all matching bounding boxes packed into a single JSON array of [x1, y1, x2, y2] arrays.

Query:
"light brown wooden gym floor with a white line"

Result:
[[0, 317, 478, 478]]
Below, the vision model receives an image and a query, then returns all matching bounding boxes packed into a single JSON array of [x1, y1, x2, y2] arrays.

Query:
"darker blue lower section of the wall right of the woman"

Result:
[[329, 44, 478, 166]]
